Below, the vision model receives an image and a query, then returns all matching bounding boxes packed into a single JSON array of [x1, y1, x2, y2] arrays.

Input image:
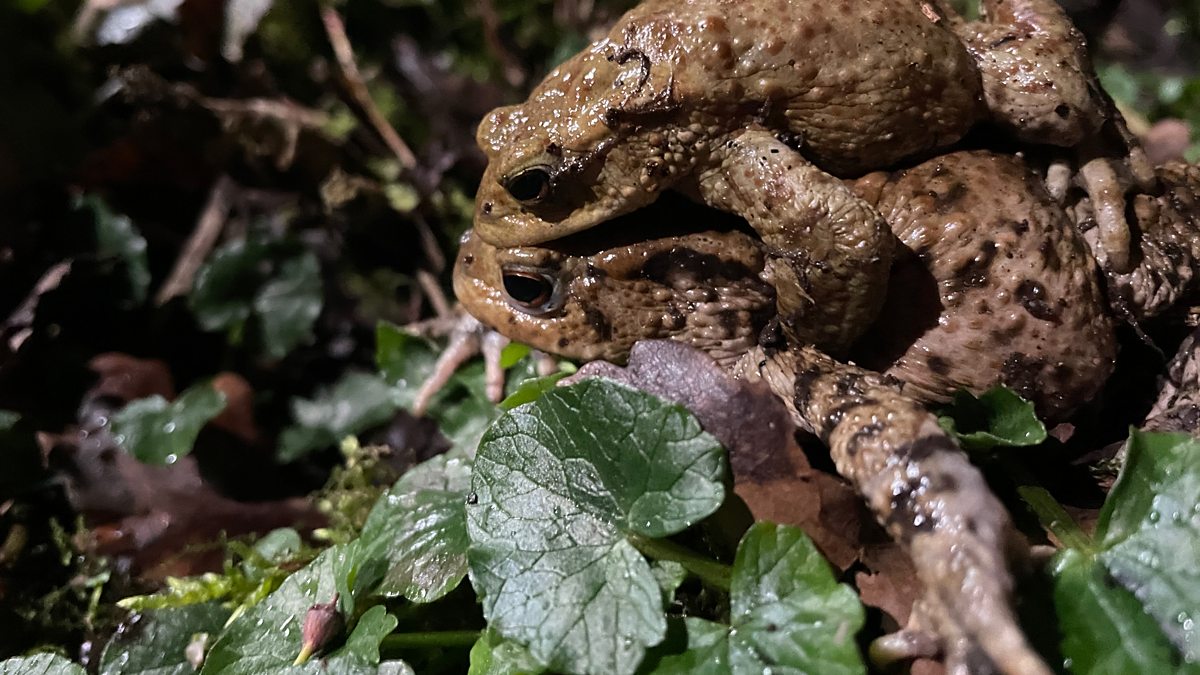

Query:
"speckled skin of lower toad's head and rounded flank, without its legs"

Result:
[[455, 153, 1116, 418]]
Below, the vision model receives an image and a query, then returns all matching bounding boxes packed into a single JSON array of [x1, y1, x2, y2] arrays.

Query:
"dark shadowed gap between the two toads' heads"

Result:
[[539, 190, 758, 257]]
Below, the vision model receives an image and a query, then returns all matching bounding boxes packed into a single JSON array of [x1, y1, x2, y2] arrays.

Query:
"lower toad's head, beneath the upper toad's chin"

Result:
[[454, 224, 775, 365]]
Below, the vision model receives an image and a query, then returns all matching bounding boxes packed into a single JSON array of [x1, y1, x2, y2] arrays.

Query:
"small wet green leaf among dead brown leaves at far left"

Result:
[[113, 382, 226, 464]]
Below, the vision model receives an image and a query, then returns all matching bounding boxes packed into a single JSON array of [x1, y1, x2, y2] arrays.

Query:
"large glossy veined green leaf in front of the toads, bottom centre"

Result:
[[467, 380, 725, 673]]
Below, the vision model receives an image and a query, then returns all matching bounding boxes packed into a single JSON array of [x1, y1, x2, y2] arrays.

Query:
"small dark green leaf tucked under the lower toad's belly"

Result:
[[937, 387, 1046, 450]]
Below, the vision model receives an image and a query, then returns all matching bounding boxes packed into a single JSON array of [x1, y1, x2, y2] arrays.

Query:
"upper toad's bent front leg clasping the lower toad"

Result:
[[685, 130, 895, 352]]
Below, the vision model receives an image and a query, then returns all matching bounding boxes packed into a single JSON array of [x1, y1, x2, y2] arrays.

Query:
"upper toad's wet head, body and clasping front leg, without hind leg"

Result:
[[475, 0, 984, 351]]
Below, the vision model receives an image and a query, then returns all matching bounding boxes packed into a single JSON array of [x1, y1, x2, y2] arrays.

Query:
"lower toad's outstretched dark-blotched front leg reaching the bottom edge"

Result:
[[739, 347, 1050, 675]]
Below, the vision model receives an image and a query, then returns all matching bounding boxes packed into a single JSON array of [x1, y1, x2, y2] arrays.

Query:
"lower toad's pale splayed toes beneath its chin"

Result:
[[406, 307, 557, 417]]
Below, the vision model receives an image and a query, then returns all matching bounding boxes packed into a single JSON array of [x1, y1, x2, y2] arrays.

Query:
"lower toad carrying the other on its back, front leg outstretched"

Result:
[[436, 153, 1200, 673]]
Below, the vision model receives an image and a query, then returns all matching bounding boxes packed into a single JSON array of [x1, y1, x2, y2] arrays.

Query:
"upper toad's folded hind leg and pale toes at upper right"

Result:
[[942, 0, 1154, 273]]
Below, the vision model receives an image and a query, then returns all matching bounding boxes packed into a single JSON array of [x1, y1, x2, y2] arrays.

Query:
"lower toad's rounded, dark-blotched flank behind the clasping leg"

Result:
[[853, 153, 1113, 419]]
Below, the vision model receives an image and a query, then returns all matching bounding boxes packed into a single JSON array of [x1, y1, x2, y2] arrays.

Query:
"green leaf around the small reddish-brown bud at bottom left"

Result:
[[202, 544, 396, 675]]
